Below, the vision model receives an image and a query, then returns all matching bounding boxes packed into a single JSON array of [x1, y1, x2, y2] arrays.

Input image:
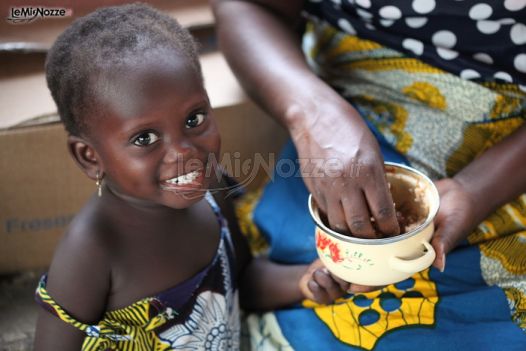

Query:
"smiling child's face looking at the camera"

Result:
[[88, 57, 220, 208]]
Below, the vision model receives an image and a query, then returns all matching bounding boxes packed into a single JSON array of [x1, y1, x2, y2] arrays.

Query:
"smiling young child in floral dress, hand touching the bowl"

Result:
[[35, 4, 348, 351]]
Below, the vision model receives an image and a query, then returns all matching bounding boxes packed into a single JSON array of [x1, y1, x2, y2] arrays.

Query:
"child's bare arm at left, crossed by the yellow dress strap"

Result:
[[34, 224, 110, 351]]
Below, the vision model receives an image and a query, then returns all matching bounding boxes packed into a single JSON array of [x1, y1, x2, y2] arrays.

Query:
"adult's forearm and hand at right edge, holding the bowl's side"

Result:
[[433, 124, 526, 269]]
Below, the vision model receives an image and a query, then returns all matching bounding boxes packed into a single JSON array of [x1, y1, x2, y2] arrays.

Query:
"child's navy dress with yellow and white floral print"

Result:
[[36, 193, 240, 351]]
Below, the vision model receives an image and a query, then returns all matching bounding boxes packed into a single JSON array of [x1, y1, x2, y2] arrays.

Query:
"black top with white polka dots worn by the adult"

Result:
[[306, 0, 526, 86]]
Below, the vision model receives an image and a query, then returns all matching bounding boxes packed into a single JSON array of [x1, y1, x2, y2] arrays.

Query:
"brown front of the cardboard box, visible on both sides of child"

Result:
[[0, 102, 286, 273]]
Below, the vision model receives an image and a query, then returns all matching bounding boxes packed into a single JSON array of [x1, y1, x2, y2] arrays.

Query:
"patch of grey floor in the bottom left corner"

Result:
[[0, 271, 43, 351]]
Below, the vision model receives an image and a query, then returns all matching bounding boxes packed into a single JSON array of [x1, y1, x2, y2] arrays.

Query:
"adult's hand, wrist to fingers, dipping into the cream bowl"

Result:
[[291, 97, 400, 238]]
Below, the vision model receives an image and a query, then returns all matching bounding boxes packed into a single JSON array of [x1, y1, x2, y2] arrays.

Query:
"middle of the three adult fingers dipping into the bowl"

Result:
[[342, 189, 376, 239]]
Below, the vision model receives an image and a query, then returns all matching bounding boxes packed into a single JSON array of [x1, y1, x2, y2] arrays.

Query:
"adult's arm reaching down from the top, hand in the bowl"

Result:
[[212, 0, 399, 237]]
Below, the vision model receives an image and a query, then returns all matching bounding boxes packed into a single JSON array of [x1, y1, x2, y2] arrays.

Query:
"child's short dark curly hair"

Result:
[[46, 4, 202, 135]]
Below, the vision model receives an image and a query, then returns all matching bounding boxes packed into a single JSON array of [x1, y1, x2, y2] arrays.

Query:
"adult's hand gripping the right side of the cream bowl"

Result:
[[431, 178, 478, 271]]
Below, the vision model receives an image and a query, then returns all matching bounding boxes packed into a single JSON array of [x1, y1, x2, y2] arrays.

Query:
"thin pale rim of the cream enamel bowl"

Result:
[[308, 162, 440, 245]]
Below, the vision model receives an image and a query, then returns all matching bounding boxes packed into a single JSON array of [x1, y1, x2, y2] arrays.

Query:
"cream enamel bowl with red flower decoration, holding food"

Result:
[[308, 162, 440, 286]]
